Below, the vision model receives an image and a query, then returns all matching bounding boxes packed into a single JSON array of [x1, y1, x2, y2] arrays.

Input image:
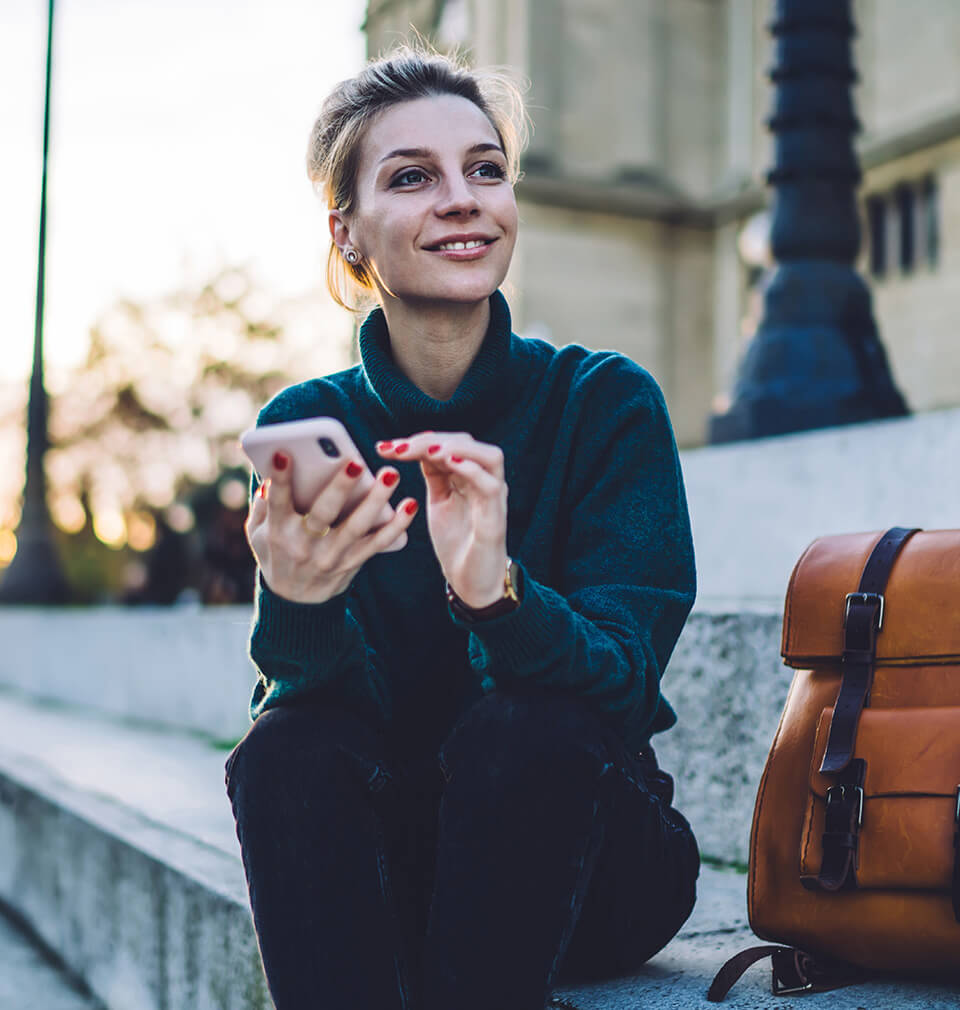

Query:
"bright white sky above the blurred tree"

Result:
[[0, 0, 365, 382]]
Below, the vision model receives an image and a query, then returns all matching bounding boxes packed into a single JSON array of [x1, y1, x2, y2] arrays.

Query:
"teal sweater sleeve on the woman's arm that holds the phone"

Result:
[[250, 387, 392, 725]]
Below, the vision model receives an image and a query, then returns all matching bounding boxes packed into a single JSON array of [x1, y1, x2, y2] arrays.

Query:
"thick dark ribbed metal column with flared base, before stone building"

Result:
[[709, 0, 907, 442]]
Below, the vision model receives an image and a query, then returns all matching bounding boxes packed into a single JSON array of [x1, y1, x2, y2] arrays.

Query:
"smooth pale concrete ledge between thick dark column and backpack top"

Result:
[[680, 409, 960, 606]]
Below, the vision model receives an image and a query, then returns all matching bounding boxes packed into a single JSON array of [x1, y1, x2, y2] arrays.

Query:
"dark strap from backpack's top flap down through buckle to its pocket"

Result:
[[820, 526, 918, 774]]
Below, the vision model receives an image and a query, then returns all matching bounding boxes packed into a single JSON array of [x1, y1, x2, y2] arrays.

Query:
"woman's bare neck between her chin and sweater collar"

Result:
[[383, 299, 490, 402]]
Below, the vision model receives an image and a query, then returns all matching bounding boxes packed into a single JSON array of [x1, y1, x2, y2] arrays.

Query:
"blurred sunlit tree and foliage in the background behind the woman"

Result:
[[0, 268, 352, 602]]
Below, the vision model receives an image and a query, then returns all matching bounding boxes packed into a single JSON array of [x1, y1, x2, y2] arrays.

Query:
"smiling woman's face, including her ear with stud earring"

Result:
[[330, 95, 517, 308]]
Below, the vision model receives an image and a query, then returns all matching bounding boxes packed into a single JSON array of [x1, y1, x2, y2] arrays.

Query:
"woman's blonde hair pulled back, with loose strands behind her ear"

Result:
[[306, 45, 526, 311]]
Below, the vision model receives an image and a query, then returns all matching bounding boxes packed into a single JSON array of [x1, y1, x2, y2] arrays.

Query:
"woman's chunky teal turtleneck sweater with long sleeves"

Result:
[[250, 292, 695, 756]]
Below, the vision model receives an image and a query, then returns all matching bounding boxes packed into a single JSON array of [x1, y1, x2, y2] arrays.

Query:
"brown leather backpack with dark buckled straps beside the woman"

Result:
[[707, 528, 960, 1002]]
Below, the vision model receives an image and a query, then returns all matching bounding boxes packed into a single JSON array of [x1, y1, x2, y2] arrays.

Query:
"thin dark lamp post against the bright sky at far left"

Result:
[[0, 0, 69, 603]]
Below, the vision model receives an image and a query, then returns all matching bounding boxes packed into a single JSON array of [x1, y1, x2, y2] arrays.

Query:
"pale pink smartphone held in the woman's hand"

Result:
[[241, 417, 406, 550]]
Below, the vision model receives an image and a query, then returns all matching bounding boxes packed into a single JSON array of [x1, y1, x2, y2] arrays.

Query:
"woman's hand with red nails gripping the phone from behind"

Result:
[[245, 452, 417, 603]]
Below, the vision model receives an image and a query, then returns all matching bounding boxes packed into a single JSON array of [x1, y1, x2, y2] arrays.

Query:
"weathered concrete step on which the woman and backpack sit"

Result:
[[0, 692, 960, 1010]]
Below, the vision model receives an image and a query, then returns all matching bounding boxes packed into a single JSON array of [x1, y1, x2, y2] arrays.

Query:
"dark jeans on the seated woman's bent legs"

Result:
[[226, 693, 699, 1010]]
